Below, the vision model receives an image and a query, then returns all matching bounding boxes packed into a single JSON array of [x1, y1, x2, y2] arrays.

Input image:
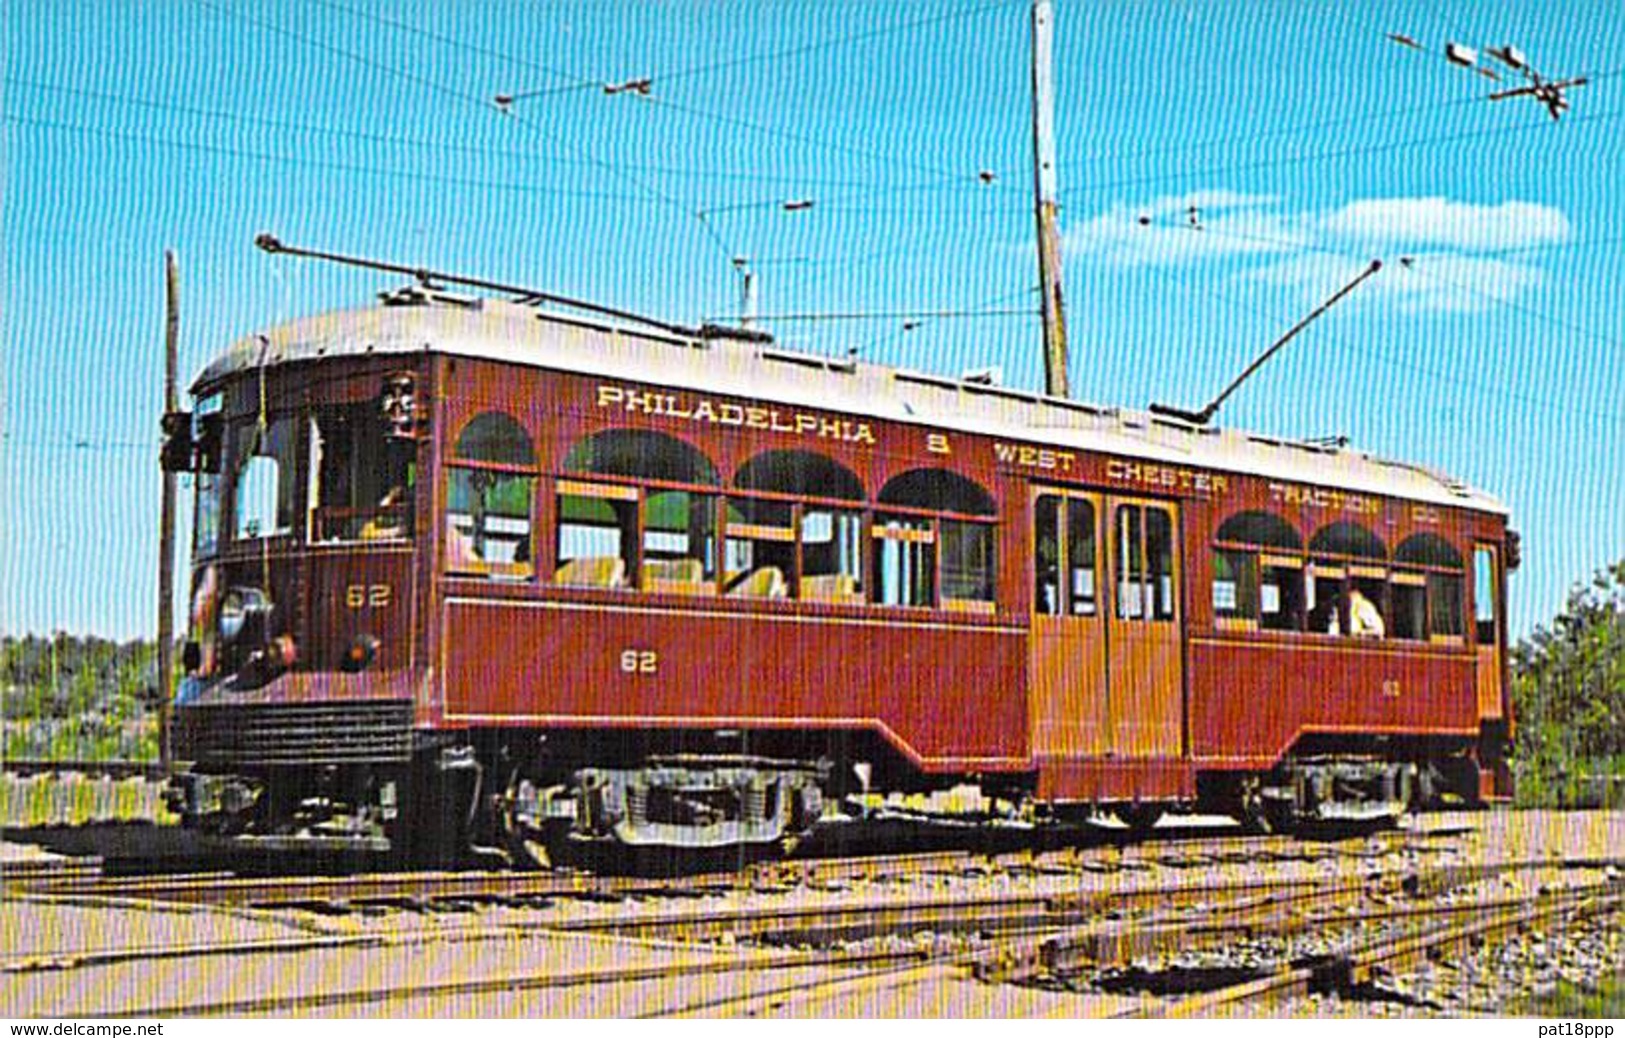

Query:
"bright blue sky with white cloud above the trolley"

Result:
[[0, 0, 1625, 637]]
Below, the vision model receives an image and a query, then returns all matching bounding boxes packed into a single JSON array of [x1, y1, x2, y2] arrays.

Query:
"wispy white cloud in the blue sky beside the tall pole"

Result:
[[1063, 188, 1573, 312]]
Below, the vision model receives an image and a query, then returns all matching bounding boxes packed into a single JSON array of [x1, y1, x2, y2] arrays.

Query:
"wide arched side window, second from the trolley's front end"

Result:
[[554, 429, 717, 595]]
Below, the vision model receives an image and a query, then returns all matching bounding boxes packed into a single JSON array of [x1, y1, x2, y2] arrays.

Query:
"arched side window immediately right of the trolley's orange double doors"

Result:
[[1212, 510, 1303, 630]]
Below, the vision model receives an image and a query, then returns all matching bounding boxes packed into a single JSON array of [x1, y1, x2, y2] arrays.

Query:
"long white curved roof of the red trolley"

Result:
[[193, 296, 1506, 515]]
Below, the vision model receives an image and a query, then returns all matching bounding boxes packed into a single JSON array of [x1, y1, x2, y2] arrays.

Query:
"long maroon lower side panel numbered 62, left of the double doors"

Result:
[[445, 599, 1027, 770]]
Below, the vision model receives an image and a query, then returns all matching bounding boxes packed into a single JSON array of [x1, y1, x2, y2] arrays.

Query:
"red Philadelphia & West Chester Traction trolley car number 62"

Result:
[[167, 269, 1515, 850]]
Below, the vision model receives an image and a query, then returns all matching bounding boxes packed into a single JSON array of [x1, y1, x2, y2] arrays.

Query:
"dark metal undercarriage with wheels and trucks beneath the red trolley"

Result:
[[167, 721, 1477, 867]]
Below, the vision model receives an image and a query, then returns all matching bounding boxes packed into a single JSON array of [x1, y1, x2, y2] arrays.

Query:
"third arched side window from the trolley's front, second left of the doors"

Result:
[[723, 450, 863, 603]]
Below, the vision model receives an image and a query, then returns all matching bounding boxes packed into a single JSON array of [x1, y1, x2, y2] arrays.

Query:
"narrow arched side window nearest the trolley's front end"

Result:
[[445, 411, 536, 577]]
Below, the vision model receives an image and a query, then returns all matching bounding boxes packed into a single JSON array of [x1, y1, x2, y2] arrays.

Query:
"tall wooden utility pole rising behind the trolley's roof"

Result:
[[1032, 0, 1071, 396]]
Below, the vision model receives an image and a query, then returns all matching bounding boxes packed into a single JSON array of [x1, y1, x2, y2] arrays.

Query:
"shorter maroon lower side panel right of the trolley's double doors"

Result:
[[1190, 635, 1479, 760]]
